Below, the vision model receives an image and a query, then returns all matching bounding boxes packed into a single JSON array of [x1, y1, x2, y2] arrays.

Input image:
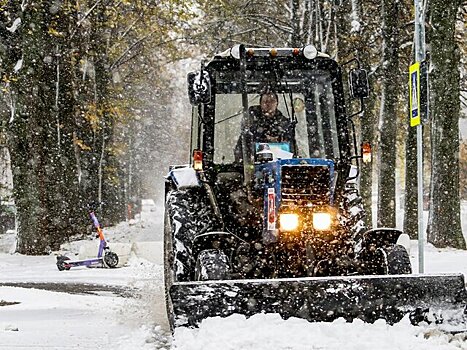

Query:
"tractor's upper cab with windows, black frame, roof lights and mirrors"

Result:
[[188, 46, 368, 172]]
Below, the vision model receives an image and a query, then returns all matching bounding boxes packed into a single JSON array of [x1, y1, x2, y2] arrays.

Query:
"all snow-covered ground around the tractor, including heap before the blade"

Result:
[[0, 206, 467, 350]]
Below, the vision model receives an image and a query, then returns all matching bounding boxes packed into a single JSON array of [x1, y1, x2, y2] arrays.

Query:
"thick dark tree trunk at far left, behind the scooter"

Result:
[[8, 1, 80, 255]]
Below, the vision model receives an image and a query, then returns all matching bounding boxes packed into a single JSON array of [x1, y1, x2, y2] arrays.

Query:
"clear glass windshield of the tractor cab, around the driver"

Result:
[[214, 71, 339, 164]]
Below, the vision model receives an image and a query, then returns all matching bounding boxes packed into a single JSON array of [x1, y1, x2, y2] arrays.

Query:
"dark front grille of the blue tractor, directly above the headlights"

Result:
[[281, 165, 331, 206]]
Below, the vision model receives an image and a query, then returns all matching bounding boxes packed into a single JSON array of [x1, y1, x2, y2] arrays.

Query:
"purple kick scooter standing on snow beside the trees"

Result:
[[57, 212, 118, 271]]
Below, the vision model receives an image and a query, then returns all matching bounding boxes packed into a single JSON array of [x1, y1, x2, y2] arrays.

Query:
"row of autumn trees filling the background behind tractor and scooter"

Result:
[[0, 0, 467, 254]]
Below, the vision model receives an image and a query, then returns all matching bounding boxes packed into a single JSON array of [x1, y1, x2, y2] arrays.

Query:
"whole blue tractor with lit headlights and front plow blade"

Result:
[[164, 45, 467, 327]]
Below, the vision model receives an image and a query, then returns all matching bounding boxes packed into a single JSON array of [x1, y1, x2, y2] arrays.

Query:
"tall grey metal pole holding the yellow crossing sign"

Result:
[[411, 0, 425, 273]]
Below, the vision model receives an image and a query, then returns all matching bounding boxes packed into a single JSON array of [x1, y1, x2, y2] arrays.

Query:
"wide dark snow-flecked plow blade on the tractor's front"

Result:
[[170, 274, 467, 327]]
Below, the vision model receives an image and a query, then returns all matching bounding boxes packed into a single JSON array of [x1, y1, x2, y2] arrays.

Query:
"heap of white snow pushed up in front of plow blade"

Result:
[[173, 314, 467, 350]]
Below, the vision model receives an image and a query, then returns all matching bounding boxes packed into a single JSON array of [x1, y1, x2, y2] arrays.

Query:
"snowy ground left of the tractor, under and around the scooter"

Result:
[[0, 212, 171, 350]]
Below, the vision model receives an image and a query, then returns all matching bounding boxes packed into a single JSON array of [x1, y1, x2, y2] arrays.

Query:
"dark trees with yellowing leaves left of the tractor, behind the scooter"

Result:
[[0, 0, 194, 254]]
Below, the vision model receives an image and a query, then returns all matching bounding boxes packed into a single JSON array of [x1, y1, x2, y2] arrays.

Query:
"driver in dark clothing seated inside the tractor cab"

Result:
[[235, 88, 292, 162]]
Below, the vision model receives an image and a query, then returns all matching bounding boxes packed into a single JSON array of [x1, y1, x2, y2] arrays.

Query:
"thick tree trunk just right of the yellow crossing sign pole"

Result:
[[427, 0, 466, 249]]
